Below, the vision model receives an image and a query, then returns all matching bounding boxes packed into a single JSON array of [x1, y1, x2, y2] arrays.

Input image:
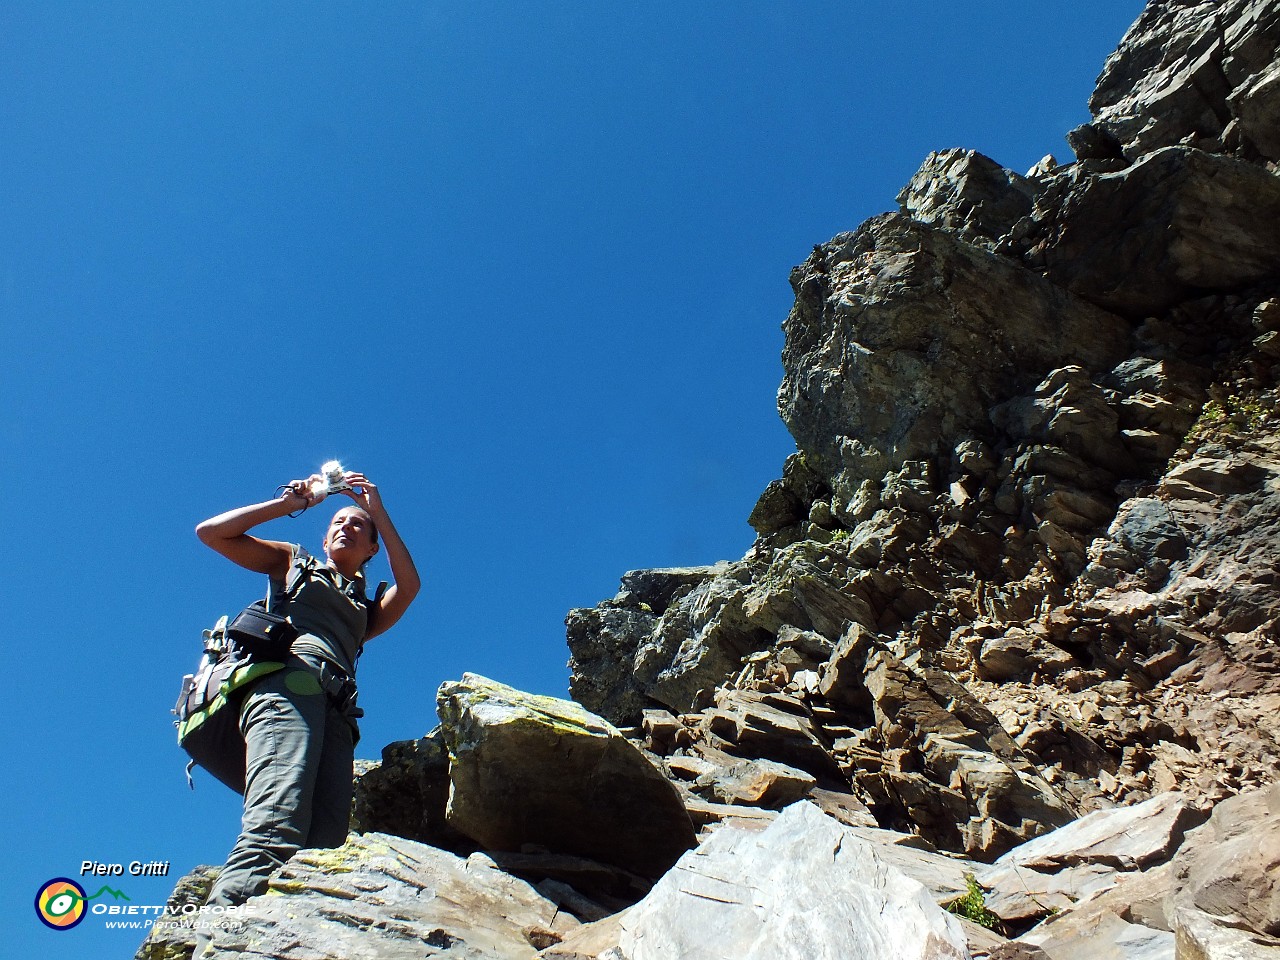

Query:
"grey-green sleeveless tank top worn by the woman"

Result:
[[271, 544, 369, 678]]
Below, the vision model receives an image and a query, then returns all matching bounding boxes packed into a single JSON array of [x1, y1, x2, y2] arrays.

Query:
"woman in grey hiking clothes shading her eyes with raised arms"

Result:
[[196, 472, 420, 916]]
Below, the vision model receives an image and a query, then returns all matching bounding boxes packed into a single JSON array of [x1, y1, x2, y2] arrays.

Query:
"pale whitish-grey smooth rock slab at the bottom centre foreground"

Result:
[[605, 801, 969, 960]]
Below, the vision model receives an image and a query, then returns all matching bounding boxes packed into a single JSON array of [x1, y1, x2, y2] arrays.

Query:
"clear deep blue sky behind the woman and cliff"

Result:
[[0, 0, 1142, 960]]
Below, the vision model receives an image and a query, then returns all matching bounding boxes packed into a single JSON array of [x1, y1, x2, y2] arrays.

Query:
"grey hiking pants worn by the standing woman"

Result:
[[209, 658, 355, 906]]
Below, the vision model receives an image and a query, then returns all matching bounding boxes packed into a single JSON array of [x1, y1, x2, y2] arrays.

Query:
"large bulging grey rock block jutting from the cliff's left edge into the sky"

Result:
[[778, 214, 1128, 504]]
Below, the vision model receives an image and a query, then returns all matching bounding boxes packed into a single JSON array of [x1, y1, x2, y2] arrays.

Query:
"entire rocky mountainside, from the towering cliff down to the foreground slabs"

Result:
[[138, 0, 1280, 960]]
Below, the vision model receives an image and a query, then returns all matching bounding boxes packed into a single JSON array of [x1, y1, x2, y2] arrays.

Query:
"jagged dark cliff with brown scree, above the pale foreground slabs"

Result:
[[568, 0, 1280, 859]]
